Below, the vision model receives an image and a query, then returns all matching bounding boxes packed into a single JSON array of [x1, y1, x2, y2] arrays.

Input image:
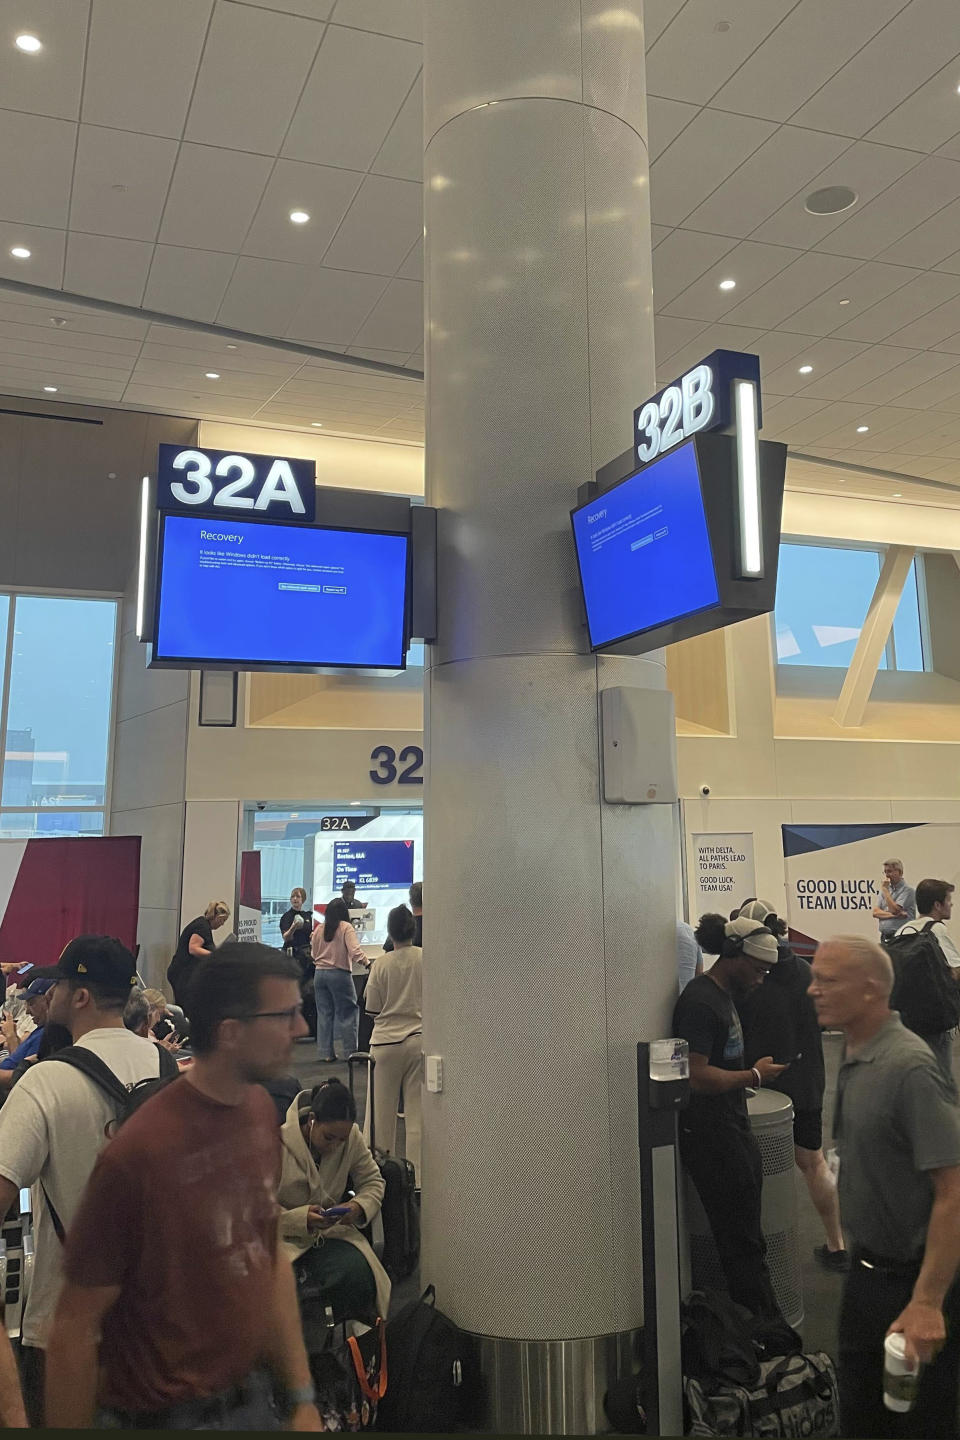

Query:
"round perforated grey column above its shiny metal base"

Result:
[[423, 0, 676, 1341]]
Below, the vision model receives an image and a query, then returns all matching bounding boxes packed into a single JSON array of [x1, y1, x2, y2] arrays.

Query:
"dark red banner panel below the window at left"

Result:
[[0, 835, 140, 965]]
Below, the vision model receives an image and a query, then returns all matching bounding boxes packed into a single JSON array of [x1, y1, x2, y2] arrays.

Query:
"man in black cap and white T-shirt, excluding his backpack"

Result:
[[0, 935, 160, 1426]]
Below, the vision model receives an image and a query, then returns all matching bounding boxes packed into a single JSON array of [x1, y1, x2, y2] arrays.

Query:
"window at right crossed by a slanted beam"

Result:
[[774, 543, 928, 671]]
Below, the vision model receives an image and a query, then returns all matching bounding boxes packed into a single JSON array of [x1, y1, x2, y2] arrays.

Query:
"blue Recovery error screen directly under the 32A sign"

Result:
[[154, 516, 407, 670]]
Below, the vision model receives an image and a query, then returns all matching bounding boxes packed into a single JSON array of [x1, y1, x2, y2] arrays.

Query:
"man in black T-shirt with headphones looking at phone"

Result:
[[674, 914, 786, 1319]]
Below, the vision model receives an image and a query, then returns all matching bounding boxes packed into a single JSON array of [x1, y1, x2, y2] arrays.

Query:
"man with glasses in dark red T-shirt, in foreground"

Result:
[[46, 943, 321, 1430]]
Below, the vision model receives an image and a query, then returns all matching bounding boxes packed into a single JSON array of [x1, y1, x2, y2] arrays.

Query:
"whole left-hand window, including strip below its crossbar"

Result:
[[0, 595, 118, 840]]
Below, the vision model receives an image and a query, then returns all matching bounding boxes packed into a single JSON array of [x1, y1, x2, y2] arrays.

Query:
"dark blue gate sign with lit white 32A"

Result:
[[157, 445, 317, 523]]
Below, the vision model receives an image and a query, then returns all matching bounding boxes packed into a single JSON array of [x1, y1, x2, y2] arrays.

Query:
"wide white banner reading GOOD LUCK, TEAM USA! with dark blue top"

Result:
[[782, 824, 960, 955]]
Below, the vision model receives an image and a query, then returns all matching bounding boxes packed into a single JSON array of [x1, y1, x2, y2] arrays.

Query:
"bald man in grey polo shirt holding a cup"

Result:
[[810, 936, 960, 1437]]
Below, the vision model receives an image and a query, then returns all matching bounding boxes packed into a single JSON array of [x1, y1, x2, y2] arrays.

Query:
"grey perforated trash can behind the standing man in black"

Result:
[[684, 1090, 803, 1328]]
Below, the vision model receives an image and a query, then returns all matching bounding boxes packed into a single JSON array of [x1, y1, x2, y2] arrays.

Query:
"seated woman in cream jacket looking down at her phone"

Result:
[[278, 1080, 390, 1320]]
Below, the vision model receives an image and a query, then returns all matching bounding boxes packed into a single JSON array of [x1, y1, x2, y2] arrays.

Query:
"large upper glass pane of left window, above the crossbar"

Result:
[[3, 595, 117, 806]]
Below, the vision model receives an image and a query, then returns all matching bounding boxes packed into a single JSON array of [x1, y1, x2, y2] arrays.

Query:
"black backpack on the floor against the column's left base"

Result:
[[377, 1284, 471, 1434]]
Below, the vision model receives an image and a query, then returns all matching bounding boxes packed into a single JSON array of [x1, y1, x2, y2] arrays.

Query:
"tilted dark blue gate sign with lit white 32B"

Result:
[[633, 350, 760, 465]]
